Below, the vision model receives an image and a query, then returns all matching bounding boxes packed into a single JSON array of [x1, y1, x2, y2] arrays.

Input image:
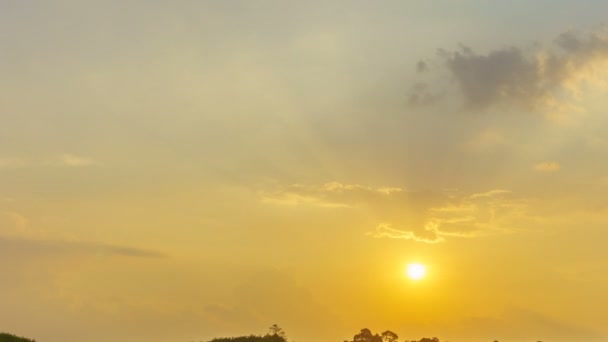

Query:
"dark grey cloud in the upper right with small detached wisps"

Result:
[[410, 27, 608, 111]]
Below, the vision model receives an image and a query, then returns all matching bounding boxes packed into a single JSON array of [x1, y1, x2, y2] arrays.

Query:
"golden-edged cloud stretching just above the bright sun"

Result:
[[261, 182, 526, 243]]
